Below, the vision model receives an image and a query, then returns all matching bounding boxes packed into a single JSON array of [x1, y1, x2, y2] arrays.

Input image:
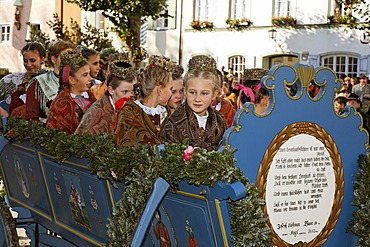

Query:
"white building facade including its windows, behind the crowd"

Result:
[[145, 0, 370, 79]]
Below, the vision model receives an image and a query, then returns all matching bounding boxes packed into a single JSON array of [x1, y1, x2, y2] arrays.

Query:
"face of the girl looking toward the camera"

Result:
[[186, 78, 215, 116]]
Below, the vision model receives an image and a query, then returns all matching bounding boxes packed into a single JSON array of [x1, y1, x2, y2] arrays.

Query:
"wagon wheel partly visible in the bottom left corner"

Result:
[[0, 196, 19, 247]]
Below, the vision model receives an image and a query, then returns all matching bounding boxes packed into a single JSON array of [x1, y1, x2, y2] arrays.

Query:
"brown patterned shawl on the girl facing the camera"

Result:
[[160, 102, 227, 151]]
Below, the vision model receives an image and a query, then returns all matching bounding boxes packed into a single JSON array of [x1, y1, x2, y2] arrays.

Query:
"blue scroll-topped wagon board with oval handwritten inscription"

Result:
[[224, 64, 368, 246]]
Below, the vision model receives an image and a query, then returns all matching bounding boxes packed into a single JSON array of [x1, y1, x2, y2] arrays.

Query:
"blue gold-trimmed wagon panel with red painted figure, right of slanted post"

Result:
[[143, 182, 231, 247]]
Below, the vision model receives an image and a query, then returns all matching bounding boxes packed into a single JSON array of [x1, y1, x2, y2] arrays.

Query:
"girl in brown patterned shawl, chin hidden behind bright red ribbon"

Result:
[[75, 53, 136, 138]]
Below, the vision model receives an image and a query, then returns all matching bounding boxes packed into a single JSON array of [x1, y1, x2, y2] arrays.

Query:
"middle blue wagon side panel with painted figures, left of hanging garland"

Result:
[[40, 154, 115, 244]]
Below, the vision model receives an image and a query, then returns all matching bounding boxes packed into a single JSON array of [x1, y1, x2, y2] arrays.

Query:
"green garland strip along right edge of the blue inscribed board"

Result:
[[347, 152, 370, 247]]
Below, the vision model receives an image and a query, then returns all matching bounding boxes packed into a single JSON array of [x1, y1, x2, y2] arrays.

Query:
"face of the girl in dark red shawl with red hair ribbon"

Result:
[[69, 65, 91, 95]]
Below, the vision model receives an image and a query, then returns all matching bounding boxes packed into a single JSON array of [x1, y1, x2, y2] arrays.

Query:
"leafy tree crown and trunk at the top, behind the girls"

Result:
[[67, 0, 166, 63]]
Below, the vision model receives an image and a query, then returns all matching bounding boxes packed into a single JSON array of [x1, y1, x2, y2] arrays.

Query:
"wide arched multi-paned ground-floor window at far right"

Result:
[[321, 55, 358, 77]]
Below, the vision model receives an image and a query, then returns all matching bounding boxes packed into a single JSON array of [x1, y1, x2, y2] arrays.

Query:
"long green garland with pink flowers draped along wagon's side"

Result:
[[2, 118, 271, 247]]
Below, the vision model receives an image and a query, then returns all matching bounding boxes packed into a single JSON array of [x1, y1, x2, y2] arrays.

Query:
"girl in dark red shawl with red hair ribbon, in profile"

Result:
[[46, 49, 96, 134]]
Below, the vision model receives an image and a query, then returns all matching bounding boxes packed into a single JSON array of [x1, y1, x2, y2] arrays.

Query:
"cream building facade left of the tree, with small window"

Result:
[[0, 0, 81, 72]]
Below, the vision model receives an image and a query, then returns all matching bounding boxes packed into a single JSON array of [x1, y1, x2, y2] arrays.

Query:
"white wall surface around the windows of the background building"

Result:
[[147, 0, 370, 74]]
